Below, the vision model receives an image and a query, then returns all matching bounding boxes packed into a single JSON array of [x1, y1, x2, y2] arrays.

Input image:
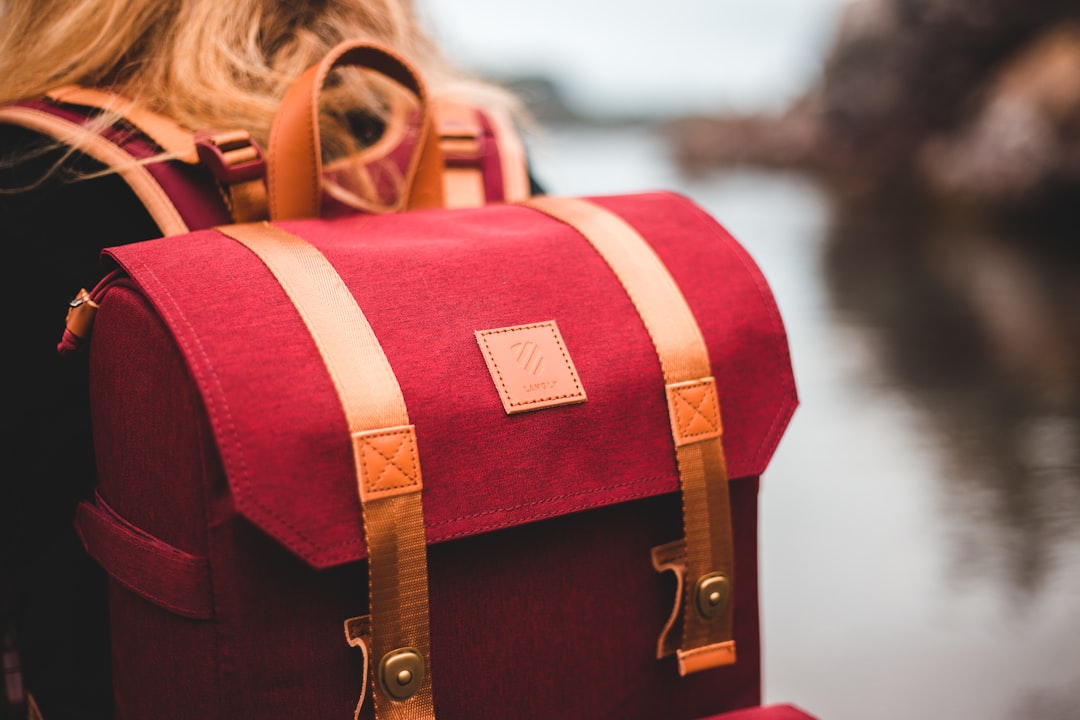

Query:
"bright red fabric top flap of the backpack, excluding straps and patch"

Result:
[[97, 193, 796, 568]]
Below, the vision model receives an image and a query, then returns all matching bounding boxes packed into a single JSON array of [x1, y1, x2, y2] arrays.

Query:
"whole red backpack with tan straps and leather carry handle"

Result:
[[0, 43, 808, 720]]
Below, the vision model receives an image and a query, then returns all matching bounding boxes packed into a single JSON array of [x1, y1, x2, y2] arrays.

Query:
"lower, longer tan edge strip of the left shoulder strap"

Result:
[[0, 105, 188, 235]]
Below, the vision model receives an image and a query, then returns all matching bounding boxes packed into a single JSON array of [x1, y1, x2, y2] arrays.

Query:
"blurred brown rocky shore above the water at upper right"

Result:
[[669, 0, 1080, 209]]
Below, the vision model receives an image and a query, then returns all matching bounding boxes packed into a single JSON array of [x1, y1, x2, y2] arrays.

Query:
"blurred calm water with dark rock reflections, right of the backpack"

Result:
[[529, 127, 1080, 720]]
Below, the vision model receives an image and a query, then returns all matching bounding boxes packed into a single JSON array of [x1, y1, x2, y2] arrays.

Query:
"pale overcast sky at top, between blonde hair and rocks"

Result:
[[416, 0, 847, 113]]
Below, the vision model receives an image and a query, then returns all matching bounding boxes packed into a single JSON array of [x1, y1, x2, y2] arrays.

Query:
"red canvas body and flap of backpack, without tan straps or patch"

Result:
[[84, 193, 796, 720]]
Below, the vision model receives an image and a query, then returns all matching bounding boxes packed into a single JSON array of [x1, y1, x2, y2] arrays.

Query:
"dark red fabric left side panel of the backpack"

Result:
[[90, 286, 225, 720]]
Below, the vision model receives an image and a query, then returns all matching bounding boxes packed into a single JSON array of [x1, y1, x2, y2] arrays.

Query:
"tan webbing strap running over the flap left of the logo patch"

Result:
[[218, 222, 434, 720]]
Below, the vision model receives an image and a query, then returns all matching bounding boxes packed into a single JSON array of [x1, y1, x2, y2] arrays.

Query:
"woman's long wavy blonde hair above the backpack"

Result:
[[0, 0, 518, 160]]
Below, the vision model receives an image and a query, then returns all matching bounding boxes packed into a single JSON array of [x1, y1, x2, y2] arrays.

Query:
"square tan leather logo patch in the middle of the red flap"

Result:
[[476, 321, 586, 415]]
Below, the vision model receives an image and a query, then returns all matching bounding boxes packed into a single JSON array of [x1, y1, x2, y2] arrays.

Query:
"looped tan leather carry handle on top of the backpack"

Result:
[[267, 41, 443, 220]]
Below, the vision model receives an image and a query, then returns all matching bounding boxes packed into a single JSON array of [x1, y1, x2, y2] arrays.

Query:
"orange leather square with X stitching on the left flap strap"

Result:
[[352, 425, 423, 502]]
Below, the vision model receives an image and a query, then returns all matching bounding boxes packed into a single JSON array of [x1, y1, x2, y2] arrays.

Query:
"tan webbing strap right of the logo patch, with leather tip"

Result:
[[524, 198, 734, 675]]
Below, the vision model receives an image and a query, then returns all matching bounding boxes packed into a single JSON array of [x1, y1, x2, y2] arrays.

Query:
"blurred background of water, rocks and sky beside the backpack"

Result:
[[417, 0, 1080, 720]]
